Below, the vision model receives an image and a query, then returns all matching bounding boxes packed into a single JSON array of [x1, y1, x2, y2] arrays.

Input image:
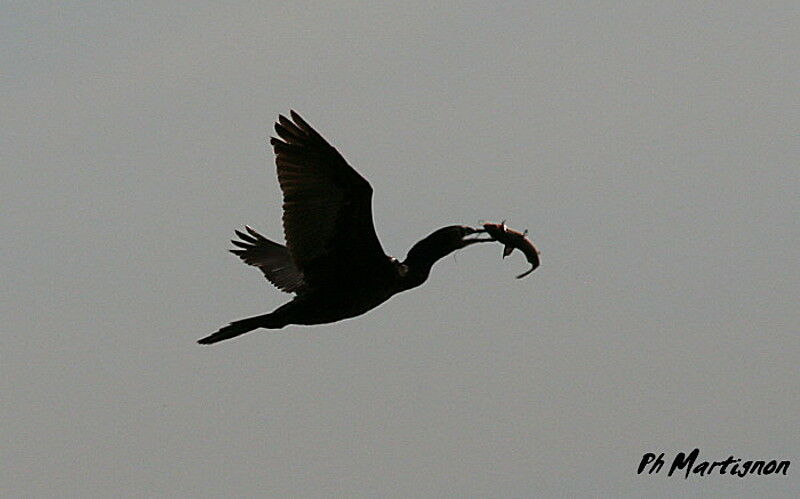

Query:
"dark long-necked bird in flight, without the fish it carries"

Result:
[[198, 111, 493, 344]]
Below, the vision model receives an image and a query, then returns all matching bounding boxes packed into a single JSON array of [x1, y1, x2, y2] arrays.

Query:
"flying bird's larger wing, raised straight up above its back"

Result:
[[270, 111, 387, 285]]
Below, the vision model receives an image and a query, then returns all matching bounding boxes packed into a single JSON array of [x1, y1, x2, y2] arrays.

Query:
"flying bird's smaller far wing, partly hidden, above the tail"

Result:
[[230, 227, 306, 293]]
